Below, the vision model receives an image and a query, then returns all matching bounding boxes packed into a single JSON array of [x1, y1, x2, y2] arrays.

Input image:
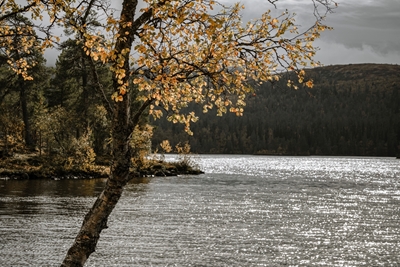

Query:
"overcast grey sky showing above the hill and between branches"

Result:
[[47, 0, 400, 66]]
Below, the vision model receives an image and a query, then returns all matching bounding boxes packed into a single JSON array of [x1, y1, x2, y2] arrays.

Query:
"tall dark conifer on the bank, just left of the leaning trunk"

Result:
[[46, 39, 111, 154]]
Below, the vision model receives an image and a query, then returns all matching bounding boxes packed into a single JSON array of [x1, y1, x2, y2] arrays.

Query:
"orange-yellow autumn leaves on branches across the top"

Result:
[[0, 0, 333, 132]]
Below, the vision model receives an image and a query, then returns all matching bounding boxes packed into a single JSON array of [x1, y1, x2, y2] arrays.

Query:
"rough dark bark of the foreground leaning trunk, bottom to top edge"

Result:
[[61, 0, 137, 267]]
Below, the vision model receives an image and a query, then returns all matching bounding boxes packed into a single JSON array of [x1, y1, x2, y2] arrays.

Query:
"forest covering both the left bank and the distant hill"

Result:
[[0, 43, 400, 161]]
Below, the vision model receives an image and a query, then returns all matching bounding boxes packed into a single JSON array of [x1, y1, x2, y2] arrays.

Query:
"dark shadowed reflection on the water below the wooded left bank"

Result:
[[0, 178, 149, 218]]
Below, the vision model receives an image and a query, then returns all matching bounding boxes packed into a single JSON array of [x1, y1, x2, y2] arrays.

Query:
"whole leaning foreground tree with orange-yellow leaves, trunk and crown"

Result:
[[0, 0, 335, 266]]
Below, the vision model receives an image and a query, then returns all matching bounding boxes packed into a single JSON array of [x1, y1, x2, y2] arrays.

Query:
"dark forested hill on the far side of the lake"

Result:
[[153, 64, 400, 156]]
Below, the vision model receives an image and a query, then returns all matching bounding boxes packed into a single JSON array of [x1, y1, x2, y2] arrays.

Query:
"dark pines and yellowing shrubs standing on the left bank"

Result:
[[0, 39, 147, 169]]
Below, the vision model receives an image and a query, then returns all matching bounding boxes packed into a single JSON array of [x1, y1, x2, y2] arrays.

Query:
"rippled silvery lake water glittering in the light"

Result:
[[0, 155, 400, 266]]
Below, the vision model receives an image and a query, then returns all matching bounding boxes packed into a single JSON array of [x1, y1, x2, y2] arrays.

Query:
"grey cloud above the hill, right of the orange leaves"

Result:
[[321, 0, 400, 64]]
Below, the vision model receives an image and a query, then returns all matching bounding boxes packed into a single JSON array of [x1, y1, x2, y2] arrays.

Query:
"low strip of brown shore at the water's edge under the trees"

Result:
[[0, 153, 204, 180]]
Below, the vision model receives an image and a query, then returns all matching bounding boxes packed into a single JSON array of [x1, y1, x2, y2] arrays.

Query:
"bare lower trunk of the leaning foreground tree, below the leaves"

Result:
[[61, 95, 131, 267]]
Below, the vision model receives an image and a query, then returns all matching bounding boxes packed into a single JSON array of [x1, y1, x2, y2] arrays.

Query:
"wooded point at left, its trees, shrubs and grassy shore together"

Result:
[[0, 40, 206, 179]]
